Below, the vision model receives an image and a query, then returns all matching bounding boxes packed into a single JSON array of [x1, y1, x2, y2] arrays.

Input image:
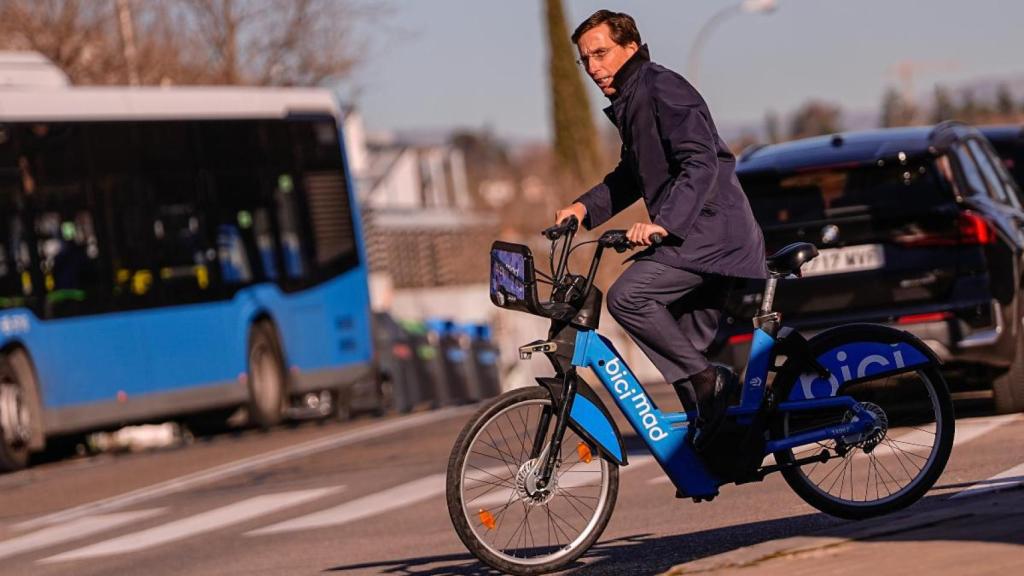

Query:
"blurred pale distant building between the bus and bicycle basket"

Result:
[[345, 111, 498, 315]]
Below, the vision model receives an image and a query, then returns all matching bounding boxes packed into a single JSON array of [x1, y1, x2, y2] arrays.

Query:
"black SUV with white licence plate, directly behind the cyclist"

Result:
[[712, 122, 1024, 412]]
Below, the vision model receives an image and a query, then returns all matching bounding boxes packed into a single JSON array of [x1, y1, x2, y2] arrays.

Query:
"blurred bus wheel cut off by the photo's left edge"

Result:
[[0, 355, 33, 471]]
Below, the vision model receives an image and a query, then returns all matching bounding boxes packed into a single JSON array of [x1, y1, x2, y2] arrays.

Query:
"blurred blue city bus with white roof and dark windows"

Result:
[[0, 88, 373, 470]]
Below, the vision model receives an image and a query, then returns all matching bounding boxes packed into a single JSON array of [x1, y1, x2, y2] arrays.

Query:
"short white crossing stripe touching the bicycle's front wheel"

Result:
[[246, 474, 445, 536]]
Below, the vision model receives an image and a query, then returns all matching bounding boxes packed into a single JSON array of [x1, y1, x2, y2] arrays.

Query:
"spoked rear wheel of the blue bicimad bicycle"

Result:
[[772, 351, 954, 519]]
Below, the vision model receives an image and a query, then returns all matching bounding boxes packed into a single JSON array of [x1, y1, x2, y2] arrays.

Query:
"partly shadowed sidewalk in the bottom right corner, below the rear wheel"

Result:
[[663, 486, 1024, 576]]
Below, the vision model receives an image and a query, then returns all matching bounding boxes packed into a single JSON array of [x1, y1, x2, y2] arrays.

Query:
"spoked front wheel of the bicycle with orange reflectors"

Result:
[[446, 387, 618, 574]]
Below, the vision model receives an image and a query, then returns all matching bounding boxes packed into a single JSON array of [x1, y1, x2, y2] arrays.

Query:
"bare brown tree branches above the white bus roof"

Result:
[[0, 0, 382, 86]]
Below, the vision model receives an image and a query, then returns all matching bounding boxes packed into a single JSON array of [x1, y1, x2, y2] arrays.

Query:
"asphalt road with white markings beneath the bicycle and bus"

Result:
[[0, 386, 1024, 576]]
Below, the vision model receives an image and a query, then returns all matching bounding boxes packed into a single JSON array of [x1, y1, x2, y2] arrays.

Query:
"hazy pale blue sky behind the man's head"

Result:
[[343, 0, 1024, 139]]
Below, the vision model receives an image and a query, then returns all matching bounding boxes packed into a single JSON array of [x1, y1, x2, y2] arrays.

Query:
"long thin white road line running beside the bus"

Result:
[[13, 406, 477, 530]]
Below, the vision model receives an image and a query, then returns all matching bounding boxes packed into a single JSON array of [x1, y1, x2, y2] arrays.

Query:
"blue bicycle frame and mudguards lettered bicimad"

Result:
[[563, 328, 936, 498]]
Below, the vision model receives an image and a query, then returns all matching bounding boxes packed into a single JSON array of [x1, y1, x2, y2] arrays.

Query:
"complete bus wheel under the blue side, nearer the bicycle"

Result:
[[249, 322, 286, 429]]
